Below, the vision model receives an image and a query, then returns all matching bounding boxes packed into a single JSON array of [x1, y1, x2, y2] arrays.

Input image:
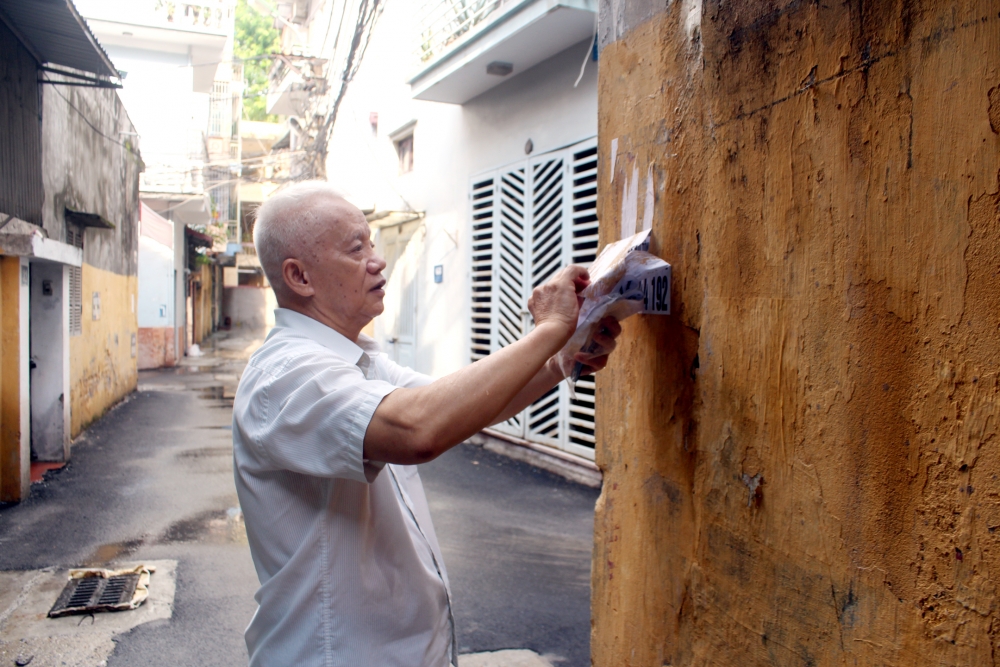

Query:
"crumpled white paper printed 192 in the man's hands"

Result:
[[555, 229, 671, 397]]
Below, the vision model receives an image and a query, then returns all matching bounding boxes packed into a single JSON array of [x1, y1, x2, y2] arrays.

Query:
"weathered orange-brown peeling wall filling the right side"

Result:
[[592, 0, 1000, 667]]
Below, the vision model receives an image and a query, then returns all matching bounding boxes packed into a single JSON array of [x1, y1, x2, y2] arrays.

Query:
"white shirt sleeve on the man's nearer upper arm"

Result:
[[252, 359, 396, 482]]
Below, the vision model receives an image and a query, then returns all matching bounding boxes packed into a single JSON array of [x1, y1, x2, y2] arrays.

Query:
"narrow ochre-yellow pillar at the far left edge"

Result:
[[0, 256, 31, 502]]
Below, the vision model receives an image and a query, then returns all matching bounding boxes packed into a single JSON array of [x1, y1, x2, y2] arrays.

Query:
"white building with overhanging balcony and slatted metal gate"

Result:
[[268, 0, 598, 465]]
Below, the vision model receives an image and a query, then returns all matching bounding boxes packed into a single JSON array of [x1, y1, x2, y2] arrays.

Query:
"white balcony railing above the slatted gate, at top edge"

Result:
[[417, 0, 514, 63]]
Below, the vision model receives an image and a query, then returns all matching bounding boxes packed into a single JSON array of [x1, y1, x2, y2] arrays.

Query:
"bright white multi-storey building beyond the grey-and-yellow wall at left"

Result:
[[78, 0, 243, 368]]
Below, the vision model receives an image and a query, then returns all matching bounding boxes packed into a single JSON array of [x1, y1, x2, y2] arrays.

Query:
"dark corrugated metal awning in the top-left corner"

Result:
[[0, 0, 118, 77]]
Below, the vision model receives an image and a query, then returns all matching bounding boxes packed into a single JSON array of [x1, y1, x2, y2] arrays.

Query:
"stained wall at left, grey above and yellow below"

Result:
[[42, 75, 143, 437]]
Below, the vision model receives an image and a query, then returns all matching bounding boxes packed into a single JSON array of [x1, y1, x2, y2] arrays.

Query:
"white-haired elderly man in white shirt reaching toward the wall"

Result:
[[233, 183, 620, 667]]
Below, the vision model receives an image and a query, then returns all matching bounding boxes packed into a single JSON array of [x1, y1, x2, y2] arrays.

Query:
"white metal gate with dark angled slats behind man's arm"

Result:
[[471, 139, 598, 459]]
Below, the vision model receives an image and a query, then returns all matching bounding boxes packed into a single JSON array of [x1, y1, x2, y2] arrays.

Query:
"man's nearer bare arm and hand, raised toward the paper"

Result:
[[364, 266, 588, 464]]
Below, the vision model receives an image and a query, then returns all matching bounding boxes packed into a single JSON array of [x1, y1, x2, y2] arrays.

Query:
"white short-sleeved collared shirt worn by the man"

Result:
[[233, 308, 455, 667]]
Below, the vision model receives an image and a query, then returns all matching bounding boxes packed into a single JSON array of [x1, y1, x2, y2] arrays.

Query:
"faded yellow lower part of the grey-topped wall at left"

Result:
[[70, 263, 139, 437]]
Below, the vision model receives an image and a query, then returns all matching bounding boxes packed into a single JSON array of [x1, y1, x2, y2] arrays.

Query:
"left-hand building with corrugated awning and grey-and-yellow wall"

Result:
[[0, 0, 143, 502]]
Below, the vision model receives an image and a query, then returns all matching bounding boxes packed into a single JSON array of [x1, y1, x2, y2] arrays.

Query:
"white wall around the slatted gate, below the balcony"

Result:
[[327, 3, 597, 376]]
